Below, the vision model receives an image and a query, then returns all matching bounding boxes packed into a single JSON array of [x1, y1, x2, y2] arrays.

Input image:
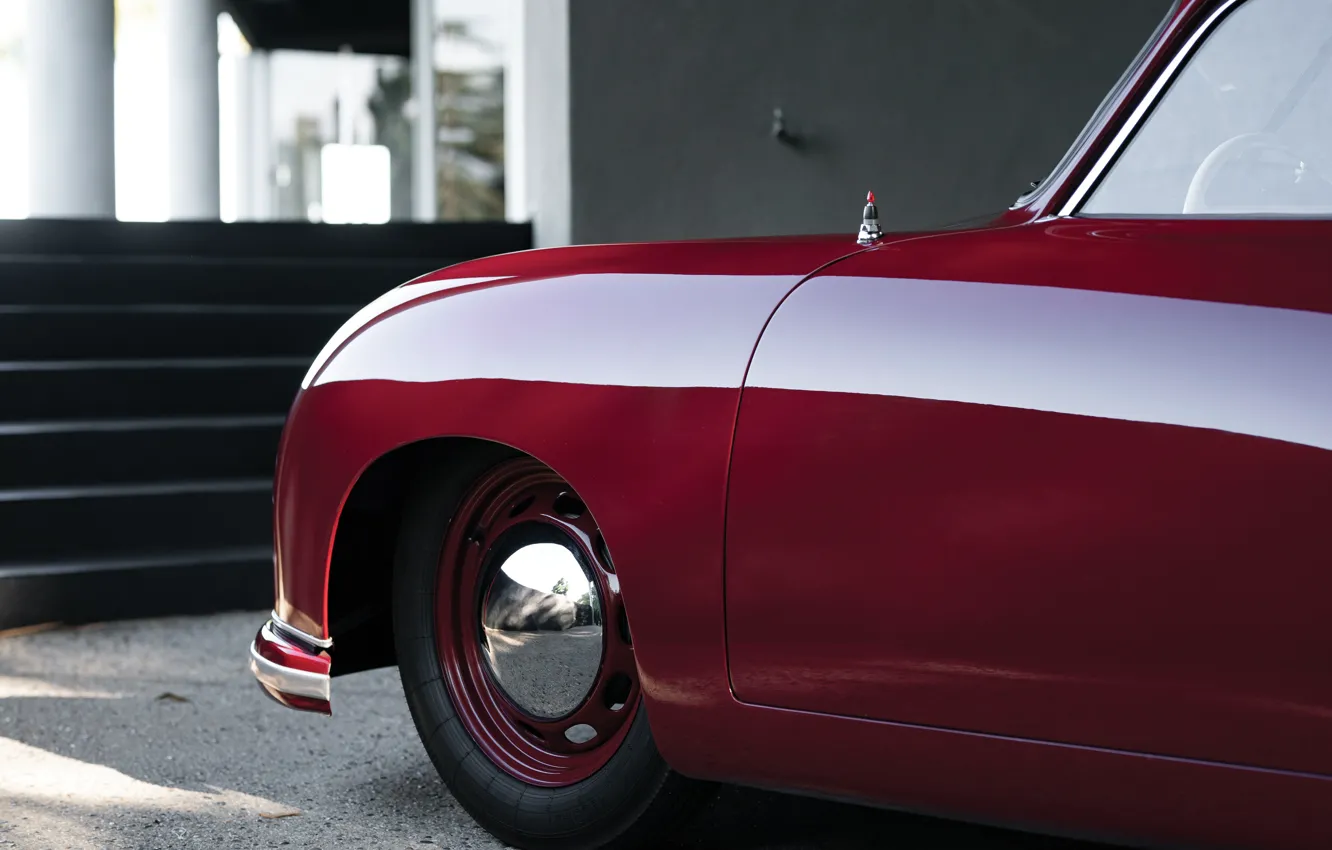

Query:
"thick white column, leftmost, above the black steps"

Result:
[[25, 0, 116, 218]]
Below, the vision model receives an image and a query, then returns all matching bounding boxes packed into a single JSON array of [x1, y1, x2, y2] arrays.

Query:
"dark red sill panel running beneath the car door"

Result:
[[671, 702, 1332, 850]]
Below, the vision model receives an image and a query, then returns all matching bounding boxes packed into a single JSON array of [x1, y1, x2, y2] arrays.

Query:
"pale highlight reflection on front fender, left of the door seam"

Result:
[[314, 274, 801, 386]]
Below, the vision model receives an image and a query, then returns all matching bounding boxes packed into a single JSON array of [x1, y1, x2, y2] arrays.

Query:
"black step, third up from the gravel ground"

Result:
[[0, 416, 282, 490]]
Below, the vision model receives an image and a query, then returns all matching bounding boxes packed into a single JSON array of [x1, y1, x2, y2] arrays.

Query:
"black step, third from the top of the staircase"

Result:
[[0, 308, 354, 361]]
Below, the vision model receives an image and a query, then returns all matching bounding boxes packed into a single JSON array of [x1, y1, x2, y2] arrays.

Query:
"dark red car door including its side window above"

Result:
[[725, 0, 1332, 774]]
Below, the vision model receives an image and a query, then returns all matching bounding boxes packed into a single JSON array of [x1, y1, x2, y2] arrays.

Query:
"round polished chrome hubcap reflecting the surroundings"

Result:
[[481, 536, 602, 719]]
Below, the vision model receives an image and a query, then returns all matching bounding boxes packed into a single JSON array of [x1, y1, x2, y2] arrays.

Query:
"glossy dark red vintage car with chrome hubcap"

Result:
[[252, 0, 1332, 850]]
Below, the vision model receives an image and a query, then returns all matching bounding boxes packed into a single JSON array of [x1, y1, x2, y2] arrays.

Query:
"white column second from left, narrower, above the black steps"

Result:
[[159, 0, 221, 220]]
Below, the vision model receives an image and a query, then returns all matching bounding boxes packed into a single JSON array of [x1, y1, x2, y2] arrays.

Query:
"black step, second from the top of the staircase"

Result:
[[0, 254, 420, 306]]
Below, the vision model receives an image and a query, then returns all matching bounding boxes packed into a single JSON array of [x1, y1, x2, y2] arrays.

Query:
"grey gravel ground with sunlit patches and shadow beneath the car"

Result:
[[0, 612, 1095, 850]]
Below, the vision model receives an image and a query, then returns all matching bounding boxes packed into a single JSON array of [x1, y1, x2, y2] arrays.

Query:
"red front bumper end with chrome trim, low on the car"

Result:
[[250, 614, 333, 714]]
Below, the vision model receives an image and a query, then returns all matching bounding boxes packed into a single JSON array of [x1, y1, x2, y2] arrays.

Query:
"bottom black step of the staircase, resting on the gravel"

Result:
[[0, 546, 273, 634]]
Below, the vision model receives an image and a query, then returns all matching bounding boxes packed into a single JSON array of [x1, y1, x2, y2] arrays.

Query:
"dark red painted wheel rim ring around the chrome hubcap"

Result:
[[436, 458, 641, 787]]
